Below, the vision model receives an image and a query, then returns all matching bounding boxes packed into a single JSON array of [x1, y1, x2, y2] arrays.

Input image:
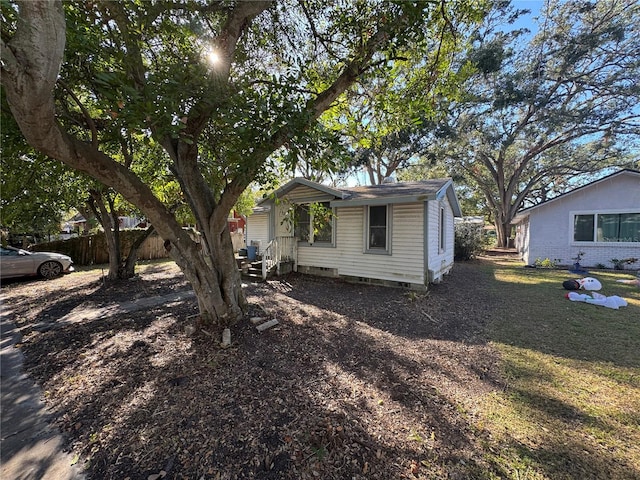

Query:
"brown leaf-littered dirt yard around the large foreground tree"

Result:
[[2, 263, 503, 480]]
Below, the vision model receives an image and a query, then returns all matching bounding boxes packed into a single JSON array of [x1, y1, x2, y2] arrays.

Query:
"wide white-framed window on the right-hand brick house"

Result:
[[573, 213, 640, 242]]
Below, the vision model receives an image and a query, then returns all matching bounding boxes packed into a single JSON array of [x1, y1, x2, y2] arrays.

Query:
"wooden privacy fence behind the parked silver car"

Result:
[[31, 230, 169, 265]]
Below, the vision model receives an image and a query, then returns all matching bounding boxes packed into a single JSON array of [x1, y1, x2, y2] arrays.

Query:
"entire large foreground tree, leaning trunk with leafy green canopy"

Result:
[[1, 0, 485, 323]]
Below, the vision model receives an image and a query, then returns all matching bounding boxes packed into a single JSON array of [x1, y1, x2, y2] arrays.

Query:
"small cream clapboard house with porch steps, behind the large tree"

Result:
[[247, 178, 461, 289]]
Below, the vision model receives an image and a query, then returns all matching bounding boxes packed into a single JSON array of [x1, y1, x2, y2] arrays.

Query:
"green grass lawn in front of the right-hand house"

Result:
[[478, 262, 640, 480]]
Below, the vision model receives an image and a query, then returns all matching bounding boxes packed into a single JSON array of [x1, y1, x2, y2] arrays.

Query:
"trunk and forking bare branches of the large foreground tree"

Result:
[[1, 0, 424, 324]]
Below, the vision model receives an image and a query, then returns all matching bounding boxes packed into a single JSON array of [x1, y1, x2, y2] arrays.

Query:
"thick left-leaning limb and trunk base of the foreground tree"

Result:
[[2, 1, 245, 324]]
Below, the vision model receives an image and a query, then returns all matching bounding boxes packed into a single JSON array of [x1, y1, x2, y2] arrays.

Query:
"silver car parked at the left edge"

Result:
[[0, 247, 73, 279]]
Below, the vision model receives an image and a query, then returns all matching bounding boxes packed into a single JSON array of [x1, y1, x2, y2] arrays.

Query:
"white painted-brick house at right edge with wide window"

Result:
[[512, 170, 640, 268]]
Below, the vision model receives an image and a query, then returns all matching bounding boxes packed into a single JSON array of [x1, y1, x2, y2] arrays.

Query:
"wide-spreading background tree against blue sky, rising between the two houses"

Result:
[[404, 0, 640, 245]]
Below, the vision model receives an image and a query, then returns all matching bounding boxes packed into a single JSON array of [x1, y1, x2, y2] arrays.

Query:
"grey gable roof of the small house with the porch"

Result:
[[258, 178, 462, 217]]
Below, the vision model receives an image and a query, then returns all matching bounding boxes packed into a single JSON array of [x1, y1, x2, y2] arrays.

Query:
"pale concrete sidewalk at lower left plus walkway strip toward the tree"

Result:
[[0, 291, 195, 480]]
